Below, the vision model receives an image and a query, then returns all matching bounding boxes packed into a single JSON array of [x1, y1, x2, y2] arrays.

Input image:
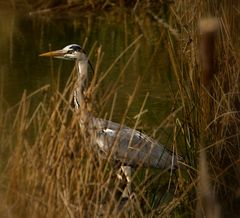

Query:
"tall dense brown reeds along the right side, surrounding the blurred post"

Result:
[[169, 1, 239, 217]]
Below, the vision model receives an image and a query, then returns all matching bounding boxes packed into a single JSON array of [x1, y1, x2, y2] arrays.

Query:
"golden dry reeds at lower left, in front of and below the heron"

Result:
[[1, 43, 182, 217]]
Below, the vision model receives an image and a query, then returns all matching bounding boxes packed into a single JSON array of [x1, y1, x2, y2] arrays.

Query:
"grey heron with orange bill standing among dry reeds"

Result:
[[40, 44, 179, 198]]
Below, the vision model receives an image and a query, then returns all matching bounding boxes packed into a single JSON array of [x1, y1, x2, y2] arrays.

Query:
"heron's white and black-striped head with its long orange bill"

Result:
[[39, 44, 88, 61]]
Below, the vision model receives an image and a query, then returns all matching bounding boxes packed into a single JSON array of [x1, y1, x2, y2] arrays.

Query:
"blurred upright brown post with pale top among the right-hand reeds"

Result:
[[196, 18, 220, 218]]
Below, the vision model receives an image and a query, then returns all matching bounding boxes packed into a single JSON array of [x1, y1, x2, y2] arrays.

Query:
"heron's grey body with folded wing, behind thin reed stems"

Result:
[[90, 118, 177, 169]]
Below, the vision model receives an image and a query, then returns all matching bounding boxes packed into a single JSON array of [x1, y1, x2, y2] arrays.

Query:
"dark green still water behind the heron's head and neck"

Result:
[[0, 5, 175, 143]]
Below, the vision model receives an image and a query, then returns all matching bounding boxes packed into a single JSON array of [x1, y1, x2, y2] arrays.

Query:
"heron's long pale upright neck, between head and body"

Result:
[[74, 58, 88, 109]]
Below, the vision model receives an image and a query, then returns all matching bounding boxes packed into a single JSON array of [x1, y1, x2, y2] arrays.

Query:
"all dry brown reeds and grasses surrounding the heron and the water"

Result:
[[0, 0, 240, 218]]
